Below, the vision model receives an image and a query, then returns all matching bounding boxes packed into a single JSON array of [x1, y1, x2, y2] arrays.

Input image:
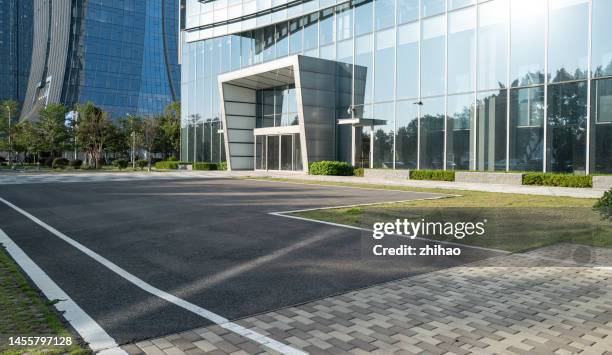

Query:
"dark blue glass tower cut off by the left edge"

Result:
[[0, 0, 33, 103]]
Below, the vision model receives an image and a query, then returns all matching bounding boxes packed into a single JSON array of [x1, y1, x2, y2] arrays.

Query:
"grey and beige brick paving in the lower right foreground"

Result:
[[123, 244, 612, 354]]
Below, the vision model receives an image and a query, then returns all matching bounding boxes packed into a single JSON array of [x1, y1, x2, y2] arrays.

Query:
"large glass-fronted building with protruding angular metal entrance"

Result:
[[181, 0, 612, 174]]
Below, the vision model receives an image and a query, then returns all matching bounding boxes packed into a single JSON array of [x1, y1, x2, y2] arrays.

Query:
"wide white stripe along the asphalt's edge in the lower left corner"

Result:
[[0, 229, 127, 354]]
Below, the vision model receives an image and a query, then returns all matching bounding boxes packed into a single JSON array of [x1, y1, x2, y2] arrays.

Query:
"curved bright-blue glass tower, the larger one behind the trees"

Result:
[[22, 0, 180, 119]]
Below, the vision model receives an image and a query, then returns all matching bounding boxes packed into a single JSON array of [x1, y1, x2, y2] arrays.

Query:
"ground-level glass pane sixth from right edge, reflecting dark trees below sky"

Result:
[[419, 97, 444, 170]]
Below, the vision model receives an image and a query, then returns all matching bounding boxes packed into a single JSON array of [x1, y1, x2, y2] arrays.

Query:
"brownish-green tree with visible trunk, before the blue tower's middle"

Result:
[[77, 102, 111, 169]]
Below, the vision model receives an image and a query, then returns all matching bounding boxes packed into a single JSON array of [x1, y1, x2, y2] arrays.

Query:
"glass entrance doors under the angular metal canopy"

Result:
[[255, 134, 302, 171]]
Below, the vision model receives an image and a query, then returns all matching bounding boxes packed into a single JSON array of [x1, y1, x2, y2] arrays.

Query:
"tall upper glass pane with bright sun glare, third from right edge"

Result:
[[510, 0, 546, 87]]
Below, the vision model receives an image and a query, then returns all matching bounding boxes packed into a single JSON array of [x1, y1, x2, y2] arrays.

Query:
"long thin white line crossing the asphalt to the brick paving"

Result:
[[0, 197, 306, 354]]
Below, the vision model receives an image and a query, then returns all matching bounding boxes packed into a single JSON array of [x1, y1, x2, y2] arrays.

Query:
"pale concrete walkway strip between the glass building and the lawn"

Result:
[[186, 171, 605, 202]]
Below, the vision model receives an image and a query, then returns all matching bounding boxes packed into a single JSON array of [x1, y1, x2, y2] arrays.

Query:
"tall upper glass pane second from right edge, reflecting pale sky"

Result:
[[548, 0, 589, 82]]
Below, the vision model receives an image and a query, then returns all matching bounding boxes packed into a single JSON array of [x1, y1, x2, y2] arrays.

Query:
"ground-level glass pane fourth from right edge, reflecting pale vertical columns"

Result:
[[475, 90, 508, 171]]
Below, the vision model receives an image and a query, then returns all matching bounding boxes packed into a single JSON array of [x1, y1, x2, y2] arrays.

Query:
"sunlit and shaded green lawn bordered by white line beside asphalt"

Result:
[[255, 179, 612, 252]]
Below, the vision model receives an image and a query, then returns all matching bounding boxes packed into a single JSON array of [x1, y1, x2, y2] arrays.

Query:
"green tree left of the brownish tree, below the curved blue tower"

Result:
[[35, 104, 70, 157]]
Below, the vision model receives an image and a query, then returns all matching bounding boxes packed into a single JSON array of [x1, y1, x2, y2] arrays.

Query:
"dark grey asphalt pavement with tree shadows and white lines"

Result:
[[0, 178, 504, 343]]
